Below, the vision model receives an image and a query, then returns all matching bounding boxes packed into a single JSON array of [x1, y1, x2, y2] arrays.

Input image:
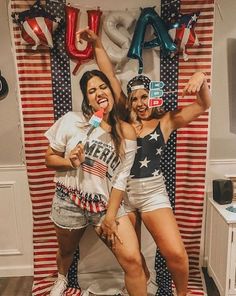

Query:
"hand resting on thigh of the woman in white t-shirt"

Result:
[[100, 218, 123, 249]]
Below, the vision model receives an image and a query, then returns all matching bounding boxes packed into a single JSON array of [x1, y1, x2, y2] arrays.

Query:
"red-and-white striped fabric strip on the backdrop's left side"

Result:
[[10, 0, 69, 296]]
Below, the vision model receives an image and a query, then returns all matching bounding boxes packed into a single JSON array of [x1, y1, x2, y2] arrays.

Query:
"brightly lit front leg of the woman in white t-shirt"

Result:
[[96, 216, 147, 296]]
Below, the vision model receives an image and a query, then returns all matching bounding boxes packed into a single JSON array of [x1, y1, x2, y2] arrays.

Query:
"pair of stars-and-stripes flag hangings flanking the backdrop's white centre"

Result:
[[9, 0, 214, 296]]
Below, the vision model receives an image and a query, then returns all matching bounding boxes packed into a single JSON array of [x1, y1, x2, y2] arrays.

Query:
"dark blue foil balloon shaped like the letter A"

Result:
[[127, 7, 177, 74]]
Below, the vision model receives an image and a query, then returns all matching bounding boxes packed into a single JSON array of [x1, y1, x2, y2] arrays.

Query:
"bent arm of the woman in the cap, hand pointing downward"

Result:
[[168, 72, 211, 131]]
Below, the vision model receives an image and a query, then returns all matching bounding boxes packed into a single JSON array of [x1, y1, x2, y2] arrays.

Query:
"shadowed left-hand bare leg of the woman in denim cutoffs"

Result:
[[55, 225, 85, 276]]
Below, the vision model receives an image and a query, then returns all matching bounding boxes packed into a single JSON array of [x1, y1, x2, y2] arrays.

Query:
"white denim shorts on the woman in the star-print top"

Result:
[[124, 175, 171, 212]]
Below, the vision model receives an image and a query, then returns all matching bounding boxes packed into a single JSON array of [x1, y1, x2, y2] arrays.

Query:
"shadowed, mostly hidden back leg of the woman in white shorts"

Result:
[[128, 212, 150, 281]]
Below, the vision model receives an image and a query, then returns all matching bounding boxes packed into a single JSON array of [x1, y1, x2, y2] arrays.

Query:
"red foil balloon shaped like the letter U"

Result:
[[65, 6, 102, 75]]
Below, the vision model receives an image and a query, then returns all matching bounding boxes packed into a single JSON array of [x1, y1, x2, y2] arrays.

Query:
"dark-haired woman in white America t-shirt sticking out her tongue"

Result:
[[45, 70, 147, 296]]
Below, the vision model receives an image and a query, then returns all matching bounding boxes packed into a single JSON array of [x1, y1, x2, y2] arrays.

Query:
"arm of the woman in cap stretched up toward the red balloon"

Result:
[[76, 28, 126, 105]]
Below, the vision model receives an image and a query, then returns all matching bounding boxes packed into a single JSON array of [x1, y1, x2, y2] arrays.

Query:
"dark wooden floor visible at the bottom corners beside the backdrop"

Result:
[[0, 268, 220, 296]]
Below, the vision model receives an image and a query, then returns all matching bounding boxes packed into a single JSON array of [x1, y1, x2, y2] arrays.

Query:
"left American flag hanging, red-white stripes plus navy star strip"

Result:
[[10, 0, 80, 296]]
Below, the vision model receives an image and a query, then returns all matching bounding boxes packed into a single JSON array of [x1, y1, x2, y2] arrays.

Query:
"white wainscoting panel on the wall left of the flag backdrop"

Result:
[[0, 165, 33, 277]]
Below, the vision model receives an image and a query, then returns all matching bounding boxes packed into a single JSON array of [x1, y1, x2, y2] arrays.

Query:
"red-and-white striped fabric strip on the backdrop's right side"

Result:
[[175, 0, 214, 295]]
